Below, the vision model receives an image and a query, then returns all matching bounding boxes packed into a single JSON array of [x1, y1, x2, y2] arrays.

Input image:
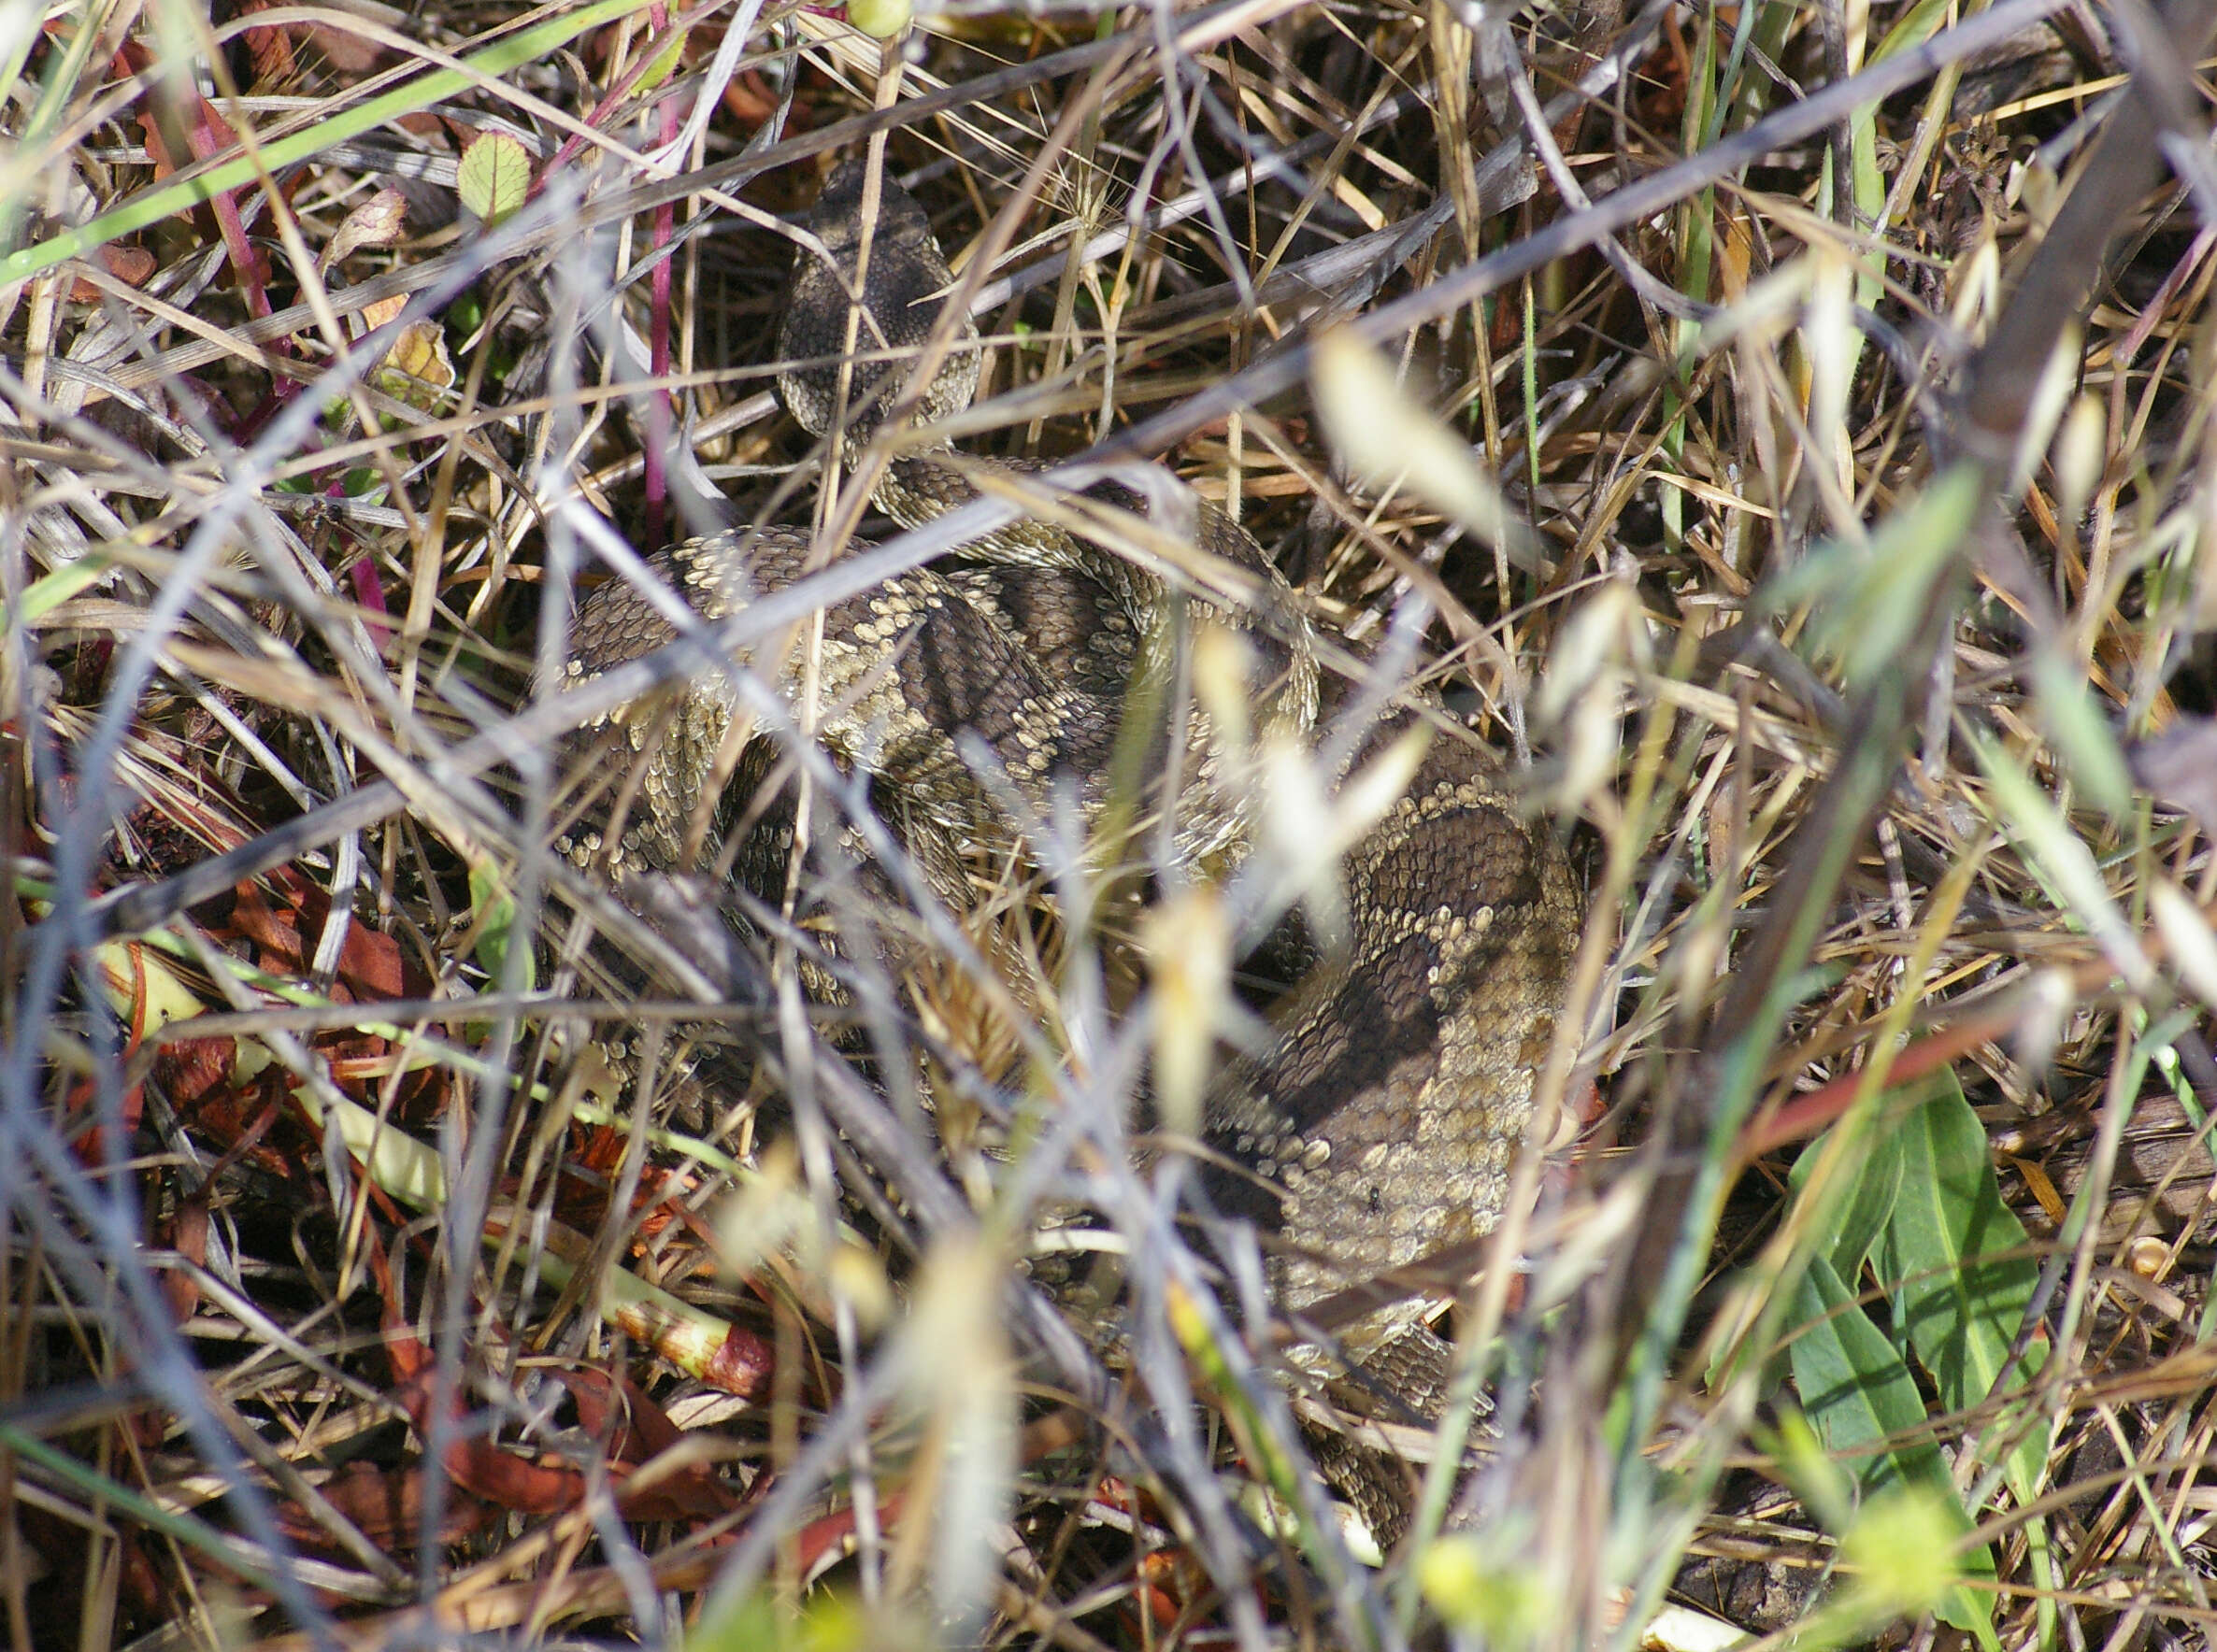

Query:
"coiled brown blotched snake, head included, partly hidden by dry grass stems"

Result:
[[563, 162, 1581, 1543]]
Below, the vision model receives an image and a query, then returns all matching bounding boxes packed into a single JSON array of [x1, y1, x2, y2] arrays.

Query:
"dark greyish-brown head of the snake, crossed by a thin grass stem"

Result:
[[779, 160, 980, 441]]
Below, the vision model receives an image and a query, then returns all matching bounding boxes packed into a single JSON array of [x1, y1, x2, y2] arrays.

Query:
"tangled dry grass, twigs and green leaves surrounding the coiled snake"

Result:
[[0, 0, 2217, 1647]]
